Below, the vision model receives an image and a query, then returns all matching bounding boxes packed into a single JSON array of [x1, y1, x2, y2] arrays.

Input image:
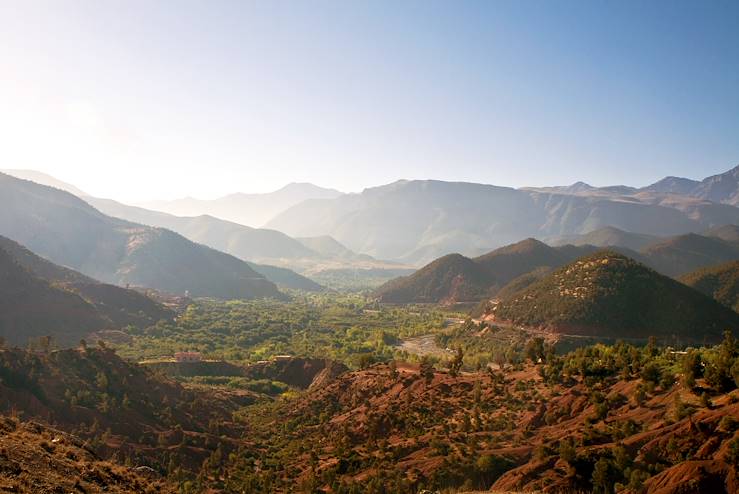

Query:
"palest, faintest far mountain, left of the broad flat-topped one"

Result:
[[141, 183, 341, 227]]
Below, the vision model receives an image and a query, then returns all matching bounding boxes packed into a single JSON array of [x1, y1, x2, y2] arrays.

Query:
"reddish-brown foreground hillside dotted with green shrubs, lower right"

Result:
[[227, 345, 739, 494]]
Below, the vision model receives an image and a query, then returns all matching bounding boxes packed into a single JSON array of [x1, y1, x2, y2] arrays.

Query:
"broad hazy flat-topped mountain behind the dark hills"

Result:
[[266, 180, 739, 265]]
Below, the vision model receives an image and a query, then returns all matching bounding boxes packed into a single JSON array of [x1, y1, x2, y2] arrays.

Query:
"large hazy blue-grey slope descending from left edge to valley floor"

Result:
[[0, 174, 281, 298]]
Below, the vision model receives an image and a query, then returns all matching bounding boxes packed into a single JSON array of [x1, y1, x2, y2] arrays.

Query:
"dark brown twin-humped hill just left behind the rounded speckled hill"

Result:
[[374, 239, 586, 304]]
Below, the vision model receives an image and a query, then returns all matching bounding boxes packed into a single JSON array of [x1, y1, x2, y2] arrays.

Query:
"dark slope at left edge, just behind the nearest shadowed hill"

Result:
[[0, 236, 174, 336]]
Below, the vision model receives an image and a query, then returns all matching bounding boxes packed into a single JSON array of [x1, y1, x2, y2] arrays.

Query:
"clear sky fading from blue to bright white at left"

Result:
[[0, 0, 739, 202]]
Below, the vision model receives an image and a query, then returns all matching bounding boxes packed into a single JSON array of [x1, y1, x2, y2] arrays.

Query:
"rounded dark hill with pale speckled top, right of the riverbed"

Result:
[[493, 251, 739, 342]]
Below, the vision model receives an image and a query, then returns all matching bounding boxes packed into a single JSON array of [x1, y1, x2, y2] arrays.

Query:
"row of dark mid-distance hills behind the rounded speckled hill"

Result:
[[375, 230, 739, 304]]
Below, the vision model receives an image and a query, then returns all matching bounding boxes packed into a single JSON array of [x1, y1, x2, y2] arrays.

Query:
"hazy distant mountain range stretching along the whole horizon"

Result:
[[5, 164, 739, 299]]
